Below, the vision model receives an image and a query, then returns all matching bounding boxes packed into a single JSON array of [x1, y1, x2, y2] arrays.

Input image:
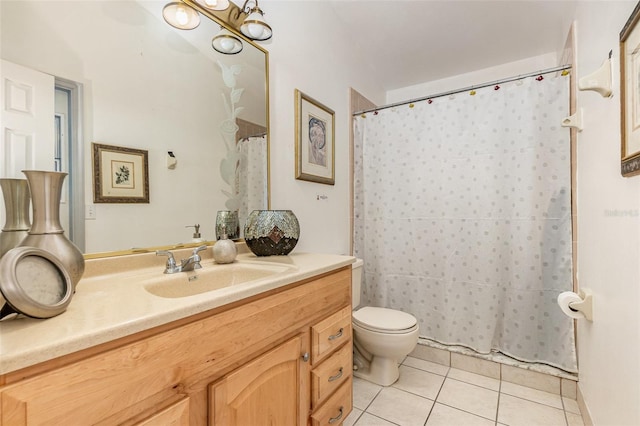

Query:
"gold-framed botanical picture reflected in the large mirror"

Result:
[[91, 143, 149, 203]]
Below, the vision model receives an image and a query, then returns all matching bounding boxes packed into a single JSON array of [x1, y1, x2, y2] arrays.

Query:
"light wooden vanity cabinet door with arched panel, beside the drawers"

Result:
[[209, 334, 309, 426]]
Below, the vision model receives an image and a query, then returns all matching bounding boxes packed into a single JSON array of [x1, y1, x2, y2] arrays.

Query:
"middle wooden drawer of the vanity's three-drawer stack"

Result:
[[311, 344, 353, 409]]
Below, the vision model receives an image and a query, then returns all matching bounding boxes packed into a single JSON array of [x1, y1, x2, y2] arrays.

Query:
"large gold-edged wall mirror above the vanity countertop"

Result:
[[0, 0, 269, 255]]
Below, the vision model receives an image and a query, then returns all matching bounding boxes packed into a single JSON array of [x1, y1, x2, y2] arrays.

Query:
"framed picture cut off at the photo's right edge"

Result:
[[620, 3, 640, 177]]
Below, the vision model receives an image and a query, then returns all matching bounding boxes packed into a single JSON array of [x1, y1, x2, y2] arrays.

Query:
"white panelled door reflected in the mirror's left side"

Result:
[[0, 60, 55, 226]]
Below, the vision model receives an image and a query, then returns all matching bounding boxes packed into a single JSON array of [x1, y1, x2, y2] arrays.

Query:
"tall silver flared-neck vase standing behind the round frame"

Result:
[[20, 170, 84, 288]]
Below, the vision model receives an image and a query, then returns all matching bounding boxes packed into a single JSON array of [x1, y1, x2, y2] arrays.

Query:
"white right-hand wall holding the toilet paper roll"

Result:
[[576, 1, 640, 425]]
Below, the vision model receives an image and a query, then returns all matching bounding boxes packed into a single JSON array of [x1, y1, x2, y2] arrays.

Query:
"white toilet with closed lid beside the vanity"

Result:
[[352, 259, 419, 386]]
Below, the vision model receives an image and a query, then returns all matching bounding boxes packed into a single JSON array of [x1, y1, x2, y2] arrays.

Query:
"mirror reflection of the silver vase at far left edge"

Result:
[[0, 179, 31, 257]]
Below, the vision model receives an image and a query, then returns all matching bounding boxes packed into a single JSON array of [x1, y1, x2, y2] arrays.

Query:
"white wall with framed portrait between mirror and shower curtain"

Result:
[[261, 1, 384, 254]]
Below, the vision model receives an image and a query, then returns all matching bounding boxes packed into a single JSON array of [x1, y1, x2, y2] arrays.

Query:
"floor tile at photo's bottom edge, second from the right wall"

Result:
[[498, 392, 566, 426]]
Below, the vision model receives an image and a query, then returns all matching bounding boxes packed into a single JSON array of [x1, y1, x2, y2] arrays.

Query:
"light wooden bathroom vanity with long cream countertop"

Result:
[[0, 250, 353, 426]]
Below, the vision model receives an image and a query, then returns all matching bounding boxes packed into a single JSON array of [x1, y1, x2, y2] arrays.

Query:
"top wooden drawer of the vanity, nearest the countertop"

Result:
[[311, 306, 351, 365]]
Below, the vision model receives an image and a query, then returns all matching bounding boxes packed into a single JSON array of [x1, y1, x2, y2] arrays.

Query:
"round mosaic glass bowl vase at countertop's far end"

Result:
[[244, 210, 300, 256]]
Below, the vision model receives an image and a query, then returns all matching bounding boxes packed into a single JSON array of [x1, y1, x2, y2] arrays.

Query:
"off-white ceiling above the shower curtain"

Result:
[[330, 0, 576, 90]]
